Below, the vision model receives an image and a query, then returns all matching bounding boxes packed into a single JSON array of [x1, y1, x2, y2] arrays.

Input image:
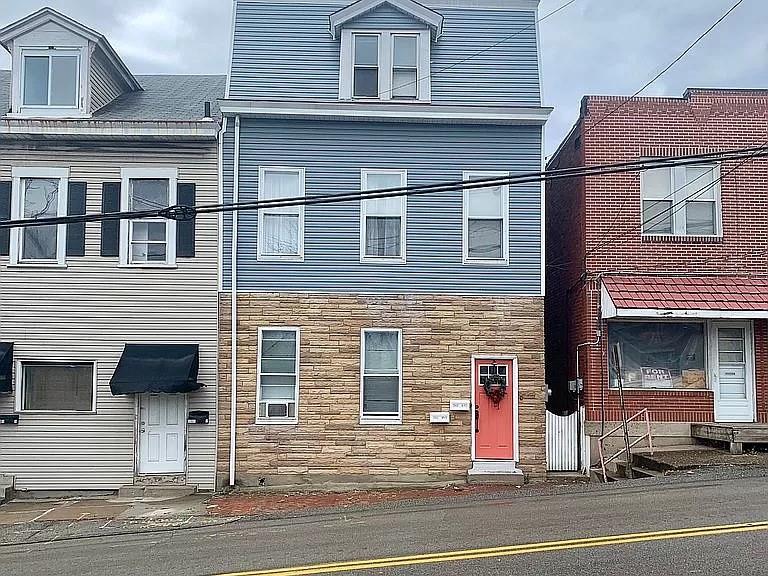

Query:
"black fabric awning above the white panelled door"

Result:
[[109, 344, 200, 396]]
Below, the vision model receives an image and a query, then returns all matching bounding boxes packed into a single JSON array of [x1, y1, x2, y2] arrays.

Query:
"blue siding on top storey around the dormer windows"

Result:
[[230, 2, 540, 106]]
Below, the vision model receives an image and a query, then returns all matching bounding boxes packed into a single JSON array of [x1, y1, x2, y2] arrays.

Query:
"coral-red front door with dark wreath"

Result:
[[475, 360, 515, 460]]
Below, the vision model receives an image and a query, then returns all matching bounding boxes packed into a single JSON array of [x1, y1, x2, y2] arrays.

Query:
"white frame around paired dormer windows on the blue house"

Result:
[[339, 28, 432, 103]]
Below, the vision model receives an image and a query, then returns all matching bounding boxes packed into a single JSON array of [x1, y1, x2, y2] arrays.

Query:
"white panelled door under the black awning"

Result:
[[139, 394, 187, 474]]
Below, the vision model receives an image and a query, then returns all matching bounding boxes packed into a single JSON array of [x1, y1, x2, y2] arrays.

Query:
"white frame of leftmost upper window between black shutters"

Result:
[[10, 166, 69, 267]]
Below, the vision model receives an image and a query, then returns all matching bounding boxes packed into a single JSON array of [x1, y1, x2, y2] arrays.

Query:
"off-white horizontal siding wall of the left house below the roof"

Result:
[[0, 143, 218, 490]]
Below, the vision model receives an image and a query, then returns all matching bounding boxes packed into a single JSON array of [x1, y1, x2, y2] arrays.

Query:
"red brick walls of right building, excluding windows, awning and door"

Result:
[[547, 90, 768, 422]]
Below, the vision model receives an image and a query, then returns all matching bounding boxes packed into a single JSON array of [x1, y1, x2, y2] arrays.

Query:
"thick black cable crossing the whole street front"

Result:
[[0, 142, 768, 229]]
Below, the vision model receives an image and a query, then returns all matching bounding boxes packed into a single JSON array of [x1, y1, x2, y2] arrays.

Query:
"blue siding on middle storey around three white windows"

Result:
[[222, 118, 541, 295]]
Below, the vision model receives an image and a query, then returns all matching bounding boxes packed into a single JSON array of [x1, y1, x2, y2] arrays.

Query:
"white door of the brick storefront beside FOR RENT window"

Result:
[[710, 322, 755, 422]]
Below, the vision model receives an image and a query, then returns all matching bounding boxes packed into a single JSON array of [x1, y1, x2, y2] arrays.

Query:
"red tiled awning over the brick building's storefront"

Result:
[[601, 276, 768, 319]]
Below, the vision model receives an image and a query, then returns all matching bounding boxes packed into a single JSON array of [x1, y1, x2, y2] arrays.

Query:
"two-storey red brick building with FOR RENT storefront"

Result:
[[546, 89, 768, 460]]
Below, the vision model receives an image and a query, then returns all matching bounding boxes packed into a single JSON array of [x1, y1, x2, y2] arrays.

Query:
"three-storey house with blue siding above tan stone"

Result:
[[219, 0, 550, 485]]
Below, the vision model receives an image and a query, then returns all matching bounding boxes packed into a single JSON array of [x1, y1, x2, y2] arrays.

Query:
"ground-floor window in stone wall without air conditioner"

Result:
[[360, 328, 403, 424]]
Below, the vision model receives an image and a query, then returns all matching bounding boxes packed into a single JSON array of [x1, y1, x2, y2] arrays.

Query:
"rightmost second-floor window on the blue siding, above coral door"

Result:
[[462, 172, 509, 265]]
